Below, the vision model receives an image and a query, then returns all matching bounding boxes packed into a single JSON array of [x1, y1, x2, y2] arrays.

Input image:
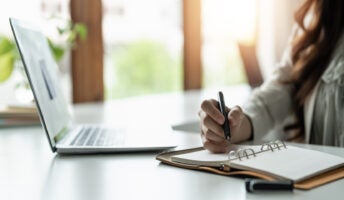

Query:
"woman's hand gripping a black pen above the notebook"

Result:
[[198, 99, 252, 153]]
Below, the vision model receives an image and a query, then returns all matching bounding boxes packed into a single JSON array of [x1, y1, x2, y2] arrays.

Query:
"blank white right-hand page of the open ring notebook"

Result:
[[231, 146, 344, 182]]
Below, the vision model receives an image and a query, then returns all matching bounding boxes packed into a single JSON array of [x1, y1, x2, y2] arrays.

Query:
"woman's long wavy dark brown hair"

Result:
[[291, 0, 344, 141]]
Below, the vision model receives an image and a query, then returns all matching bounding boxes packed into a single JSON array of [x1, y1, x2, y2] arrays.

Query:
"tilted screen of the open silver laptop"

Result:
[[10, 19, 72, 151]]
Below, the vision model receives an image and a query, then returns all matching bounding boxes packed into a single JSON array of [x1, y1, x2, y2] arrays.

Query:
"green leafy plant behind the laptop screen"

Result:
[[0, 19, 87, 83]]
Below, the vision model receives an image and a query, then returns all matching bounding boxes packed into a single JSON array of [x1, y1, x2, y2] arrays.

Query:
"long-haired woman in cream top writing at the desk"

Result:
[[199, 0, 344, 153]]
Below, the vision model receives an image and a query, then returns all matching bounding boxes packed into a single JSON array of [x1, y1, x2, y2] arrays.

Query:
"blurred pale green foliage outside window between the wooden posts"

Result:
[[106, 40, 182, 99]]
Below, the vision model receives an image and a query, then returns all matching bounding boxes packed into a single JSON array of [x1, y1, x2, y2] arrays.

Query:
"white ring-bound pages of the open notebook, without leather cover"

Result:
[[171, 142, 344, 182]]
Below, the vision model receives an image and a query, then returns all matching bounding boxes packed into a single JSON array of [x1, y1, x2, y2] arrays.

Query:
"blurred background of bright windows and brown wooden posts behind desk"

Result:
[[0, 0, 301, 104]]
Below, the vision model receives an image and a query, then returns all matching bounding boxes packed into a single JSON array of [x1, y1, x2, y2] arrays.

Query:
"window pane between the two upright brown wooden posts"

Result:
[[103, 0, 183, 99]]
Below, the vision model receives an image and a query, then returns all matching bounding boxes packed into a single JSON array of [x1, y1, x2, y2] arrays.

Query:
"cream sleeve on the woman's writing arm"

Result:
[[243, 46, 292, 139]]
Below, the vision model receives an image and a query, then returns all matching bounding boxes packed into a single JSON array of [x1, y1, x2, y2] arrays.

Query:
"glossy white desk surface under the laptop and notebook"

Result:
[[0, 88, 344, 200]]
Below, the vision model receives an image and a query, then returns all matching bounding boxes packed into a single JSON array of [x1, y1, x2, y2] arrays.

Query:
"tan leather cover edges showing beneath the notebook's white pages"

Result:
[[156, 147, 344, 190]]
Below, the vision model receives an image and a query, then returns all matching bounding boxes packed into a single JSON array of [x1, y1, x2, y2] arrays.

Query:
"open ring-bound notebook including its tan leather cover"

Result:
[[156, 141, 344, 190]]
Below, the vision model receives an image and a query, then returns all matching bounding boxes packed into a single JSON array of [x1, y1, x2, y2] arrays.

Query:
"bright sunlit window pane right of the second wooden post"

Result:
[[202, 0, 256, 87]]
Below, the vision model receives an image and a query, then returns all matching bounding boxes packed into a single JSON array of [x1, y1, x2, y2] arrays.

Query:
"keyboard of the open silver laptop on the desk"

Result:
[[71, 125, 124, 146]]
